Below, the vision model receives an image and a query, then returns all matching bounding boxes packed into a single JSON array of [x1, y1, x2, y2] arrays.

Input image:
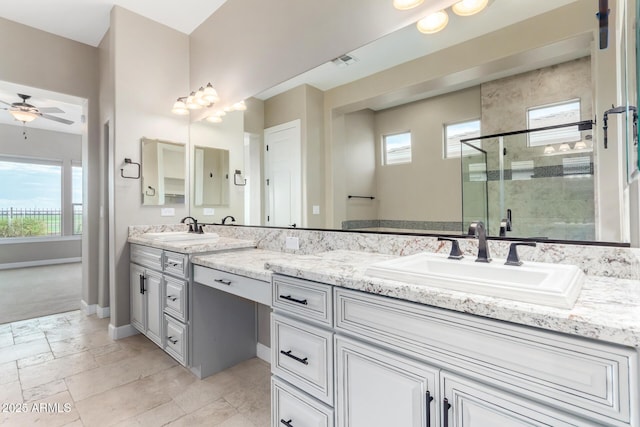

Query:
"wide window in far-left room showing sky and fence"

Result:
[[0, 158, 62, 238]]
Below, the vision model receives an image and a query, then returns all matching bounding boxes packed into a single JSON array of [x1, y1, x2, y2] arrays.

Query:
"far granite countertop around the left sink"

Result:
[[128, 234, 256, 254]]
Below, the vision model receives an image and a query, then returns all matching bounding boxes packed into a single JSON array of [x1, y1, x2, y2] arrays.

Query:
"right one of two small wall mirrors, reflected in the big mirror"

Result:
[[193, 146, 229, 206]]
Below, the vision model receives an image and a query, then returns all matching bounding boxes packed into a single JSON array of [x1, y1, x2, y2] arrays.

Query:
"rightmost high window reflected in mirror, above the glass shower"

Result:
[[527, 99, 580, 147]]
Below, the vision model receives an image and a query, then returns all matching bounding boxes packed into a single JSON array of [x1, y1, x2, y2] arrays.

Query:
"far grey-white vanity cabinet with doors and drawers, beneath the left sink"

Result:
[[130, 244, 189, 365]]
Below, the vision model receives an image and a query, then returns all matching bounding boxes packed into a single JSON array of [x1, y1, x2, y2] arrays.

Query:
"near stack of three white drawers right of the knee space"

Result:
[[271, 275, 334, 427]]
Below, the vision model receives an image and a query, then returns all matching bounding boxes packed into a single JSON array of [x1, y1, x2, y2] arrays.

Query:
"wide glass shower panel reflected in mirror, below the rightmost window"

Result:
[[463, 122, 595, 241]]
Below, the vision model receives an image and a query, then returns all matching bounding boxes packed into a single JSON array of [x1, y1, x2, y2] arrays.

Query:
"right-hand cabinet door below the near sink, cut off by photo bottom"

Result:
[[439, 372, 597, 427]]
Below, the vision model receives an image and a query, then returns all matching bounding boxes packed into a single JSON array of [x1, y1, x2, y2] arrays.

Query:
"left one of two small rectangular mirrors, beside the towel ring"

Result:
[[141, 138, 186, 205]]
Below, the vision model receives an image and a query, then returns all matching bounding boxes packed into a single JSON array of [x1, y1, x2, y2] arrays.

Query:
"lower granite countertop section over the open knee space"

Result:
[[191, 249, 301, 282]]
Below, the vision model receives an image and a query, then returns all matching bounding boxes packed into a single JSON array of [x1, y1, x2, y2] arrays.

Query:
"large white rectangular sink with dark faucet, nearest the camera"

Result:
[[365, 252, 585, 308]]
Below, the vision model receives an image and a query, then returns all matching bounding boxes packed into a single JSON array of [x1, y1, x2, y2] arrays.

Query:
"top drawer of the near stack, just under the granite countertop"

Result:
[[272, 274, 333, 326]]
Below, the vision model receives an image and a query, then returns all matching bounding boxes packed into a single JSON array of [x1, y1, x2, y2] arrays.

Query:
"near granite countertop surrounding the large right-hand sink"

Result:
[[264, 250, 640, 347]]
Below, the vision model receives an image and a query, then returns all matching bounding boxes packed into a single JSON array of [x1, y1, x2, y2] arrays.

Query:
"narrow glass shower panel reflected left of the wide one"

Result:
[[460, 141, 494, 233]]
